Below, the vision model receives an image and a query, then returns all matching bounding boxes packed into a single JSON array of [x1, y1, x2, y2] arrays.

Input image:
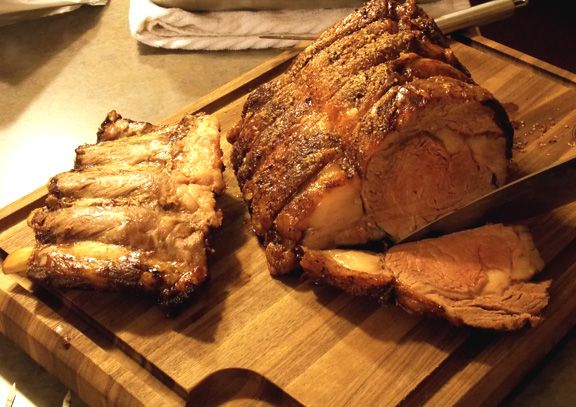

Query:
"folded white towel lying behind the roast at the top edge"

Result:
[[129, 0, 470, 50]]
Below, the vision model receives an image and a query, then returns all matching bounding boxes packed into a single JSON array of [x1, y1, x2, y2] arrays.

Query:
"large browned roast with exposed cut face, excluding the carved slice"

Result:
[[228, 0, 512, 274]]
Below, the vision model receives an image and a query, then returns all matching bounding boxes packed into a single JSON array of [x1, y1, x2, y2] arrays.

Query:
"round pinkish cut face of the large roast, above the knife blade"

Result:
[[362, 77, 508, 241]]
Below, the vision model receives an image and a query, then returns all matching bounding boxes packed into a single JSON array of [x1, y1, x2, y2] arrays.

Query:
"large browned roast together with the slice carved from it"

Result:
[[228, 0, 549, 330]]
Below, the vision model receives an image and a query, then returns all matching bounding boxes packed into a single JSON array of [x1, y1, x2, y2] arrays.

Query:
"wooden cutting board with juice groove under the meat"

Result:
[[0, 36, 576, 407]]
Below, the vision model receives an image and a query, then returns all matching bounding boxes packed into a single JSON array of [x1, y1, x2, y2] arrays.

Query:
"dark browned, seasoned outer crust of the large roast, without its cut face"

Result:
[[228, 0, 512, 276]]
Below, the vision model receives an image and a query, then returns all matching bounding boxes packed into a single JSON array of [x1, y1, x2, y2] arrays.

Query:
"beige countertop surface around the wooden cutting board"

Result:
[[0, 0, 576, 407]]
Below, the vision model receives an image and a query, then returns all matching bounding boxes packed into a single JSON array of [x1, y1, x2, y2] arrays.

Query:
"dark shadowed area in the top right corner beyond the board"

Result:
[[470, 0, 576, 73]]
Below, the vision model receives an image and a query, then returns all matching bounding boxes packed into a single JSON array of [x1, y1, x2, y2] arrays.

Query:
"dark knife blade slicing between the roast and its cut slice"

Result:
[[396, 156, 576, 244]]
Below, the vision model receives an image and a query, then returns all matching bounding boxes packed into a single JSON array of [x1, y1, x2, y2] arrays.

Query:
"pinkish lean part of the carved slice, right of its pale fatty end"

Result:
[[385, 225, 550, 330]]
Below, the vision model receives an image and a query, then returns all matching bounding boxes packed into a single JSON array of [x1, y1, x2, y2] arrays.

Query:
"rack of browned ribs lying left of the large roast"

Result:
[[27, 112, 225, 313]]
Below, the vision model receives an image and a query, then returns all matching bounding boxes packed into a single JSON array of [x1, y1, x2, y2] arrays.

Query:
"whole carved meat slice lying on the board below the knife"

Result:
[[301, 224, 550, 331]]
